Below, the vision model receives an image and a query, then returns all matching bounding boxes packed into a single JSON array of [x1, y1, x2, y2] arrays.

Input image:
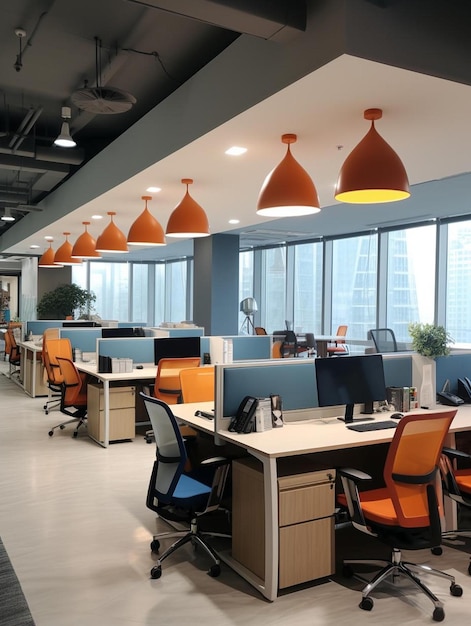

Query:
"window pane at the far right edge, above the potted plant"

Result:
[[446, 221, 471, 343]]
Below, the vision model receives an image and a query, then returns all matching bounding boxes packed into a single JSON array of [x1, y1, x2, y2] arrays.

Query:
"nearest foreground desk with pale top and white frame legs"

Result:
[[174, 403, 471, 601]]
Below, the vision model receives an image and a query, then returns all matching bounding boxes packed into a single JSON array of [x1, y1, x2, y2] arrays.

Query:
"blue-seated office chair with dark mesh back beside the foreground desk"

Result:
[[141, 393, 230, 579]]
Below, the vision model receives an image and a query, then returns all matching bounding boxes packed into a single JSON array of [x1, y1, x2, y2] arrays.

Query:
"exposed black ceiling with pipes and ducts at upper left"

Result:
[[0, 0, 305, 232]]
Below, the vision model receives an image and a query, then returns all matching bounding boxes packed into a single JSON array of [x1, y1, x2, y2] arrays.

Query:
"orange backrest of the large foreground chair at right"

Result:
[[384, 409, 456, 528]]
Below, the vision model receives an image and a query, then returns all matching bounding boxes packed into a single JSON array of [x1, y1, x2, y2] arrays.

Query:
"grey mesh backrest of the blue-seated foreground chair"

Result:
[[141, 393, 187, 502]]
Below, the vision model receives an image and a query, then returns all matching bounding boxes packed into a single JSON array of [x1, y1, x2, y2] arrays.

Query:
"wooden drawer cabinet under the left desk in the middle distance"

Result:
[[87, 383, 136, 442]]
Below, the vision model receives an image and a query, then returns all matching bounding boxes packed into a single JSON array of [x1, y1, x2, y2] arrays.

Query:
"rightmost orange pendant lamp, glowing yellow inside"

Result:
[[334, 109, 410, 204]]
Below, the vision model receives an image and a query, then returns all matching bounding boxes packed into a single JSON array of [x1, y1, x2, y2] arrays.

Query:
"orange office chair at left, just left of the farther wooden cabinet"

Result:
[[49, 356, 88, 438]]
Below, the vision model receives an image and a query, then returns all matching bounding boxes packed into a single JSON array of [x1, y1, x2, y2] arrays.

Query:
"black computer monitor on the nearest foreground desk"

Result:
[[315, 354, 386, 423]]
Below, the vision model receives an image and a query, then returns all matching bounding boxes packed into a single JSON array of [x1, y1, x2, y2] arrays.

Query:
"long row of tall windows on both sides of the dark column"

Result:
[[72, 217, 471, 344]]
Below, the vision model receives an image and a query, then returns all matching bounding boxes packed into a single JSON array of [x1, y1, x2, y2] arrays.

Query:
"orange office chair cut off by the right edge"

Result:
[[440, 448, 471, 575]]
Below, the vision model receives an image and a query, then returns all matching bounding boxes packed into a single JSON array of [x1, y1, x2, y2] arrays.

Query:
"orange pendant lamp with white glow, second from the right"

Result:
[[257, 133, 320, 217]]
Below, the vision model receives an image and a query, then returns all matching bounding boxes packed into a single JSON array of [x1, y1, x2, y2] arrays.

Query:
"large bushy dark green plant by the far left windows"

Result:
[[37, 283, 96, 319]]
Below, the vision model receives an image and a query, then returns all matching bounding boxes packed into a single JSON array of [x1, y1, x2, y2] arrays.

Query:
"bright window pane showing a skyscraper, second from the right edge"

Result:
[[386, 224, 436, 341]]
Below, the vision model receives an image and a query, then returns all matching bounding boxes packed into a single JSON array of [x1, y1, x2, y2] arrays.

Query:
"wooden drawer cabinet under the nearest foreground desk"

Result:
[[232, 458, 335, 589]]
